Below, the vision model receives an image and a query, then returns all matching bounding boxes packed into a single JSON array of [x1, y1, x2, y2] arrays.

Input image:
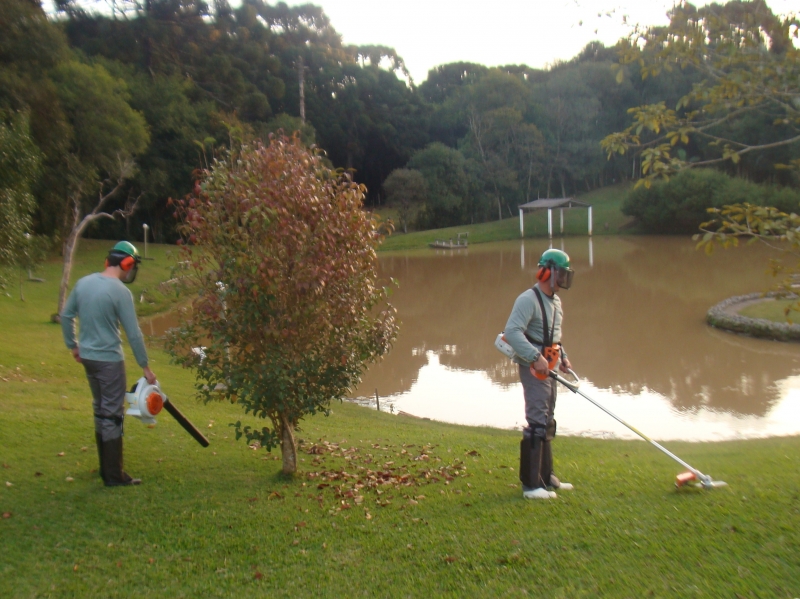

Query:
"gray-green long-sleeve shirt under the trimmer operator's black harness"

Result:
[[503, 283, 567, 365]]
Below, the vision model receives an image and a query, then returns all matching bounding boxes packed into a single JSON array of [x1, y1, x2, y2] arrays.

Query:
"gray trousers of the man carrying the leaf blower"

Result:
[[82, 360, 127, 441]]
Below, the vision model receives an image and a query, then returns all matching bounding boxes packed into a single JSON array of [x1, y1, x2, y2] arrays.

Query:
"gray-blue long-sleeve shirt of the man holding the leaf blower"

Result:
[[61, 273, 147, 368]]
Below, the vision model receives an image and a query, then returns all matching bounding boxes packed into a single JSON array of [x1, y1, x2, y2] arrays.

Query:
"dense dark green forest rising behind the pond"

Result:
[[0, 0, 797, 251]]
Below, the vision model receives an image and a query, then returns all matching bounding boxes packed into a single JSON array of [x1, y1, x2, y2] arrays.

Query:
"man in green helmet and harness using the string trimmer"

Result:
[[503, 249, 574, 499]]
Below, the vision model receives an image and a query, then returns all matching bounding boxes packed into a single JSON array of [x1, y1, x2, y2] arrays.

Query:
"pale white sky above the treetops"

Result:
[[280, 0, 797, 84]]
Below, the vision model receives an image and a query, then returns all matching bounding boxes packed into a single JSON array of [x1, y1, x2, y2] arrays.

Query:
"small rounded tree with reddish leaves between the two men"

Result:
[[168, 135, 397, 474]]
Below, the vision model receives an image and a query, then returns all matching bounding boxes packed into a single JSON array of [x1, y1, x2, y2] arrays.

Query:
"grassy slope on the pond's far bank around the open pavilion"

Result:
[[378, 183, 635, 251]]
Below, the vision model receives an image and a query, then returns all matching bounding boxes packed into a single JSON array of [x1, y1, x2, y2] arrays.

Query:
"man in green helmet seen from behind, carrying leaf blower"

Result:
[[61, 241, 156, 487]]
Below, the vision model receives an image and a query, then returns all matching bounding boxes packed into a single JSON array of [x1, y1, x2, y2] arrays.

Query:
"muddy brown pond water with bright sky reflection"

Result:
[[142, 237, 800, 440]]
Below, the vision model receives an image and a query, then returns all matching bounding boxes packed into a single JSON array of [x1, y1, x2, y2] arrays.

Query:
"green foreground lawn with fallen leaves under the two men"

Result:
[[0, 243, 800, 598]]
